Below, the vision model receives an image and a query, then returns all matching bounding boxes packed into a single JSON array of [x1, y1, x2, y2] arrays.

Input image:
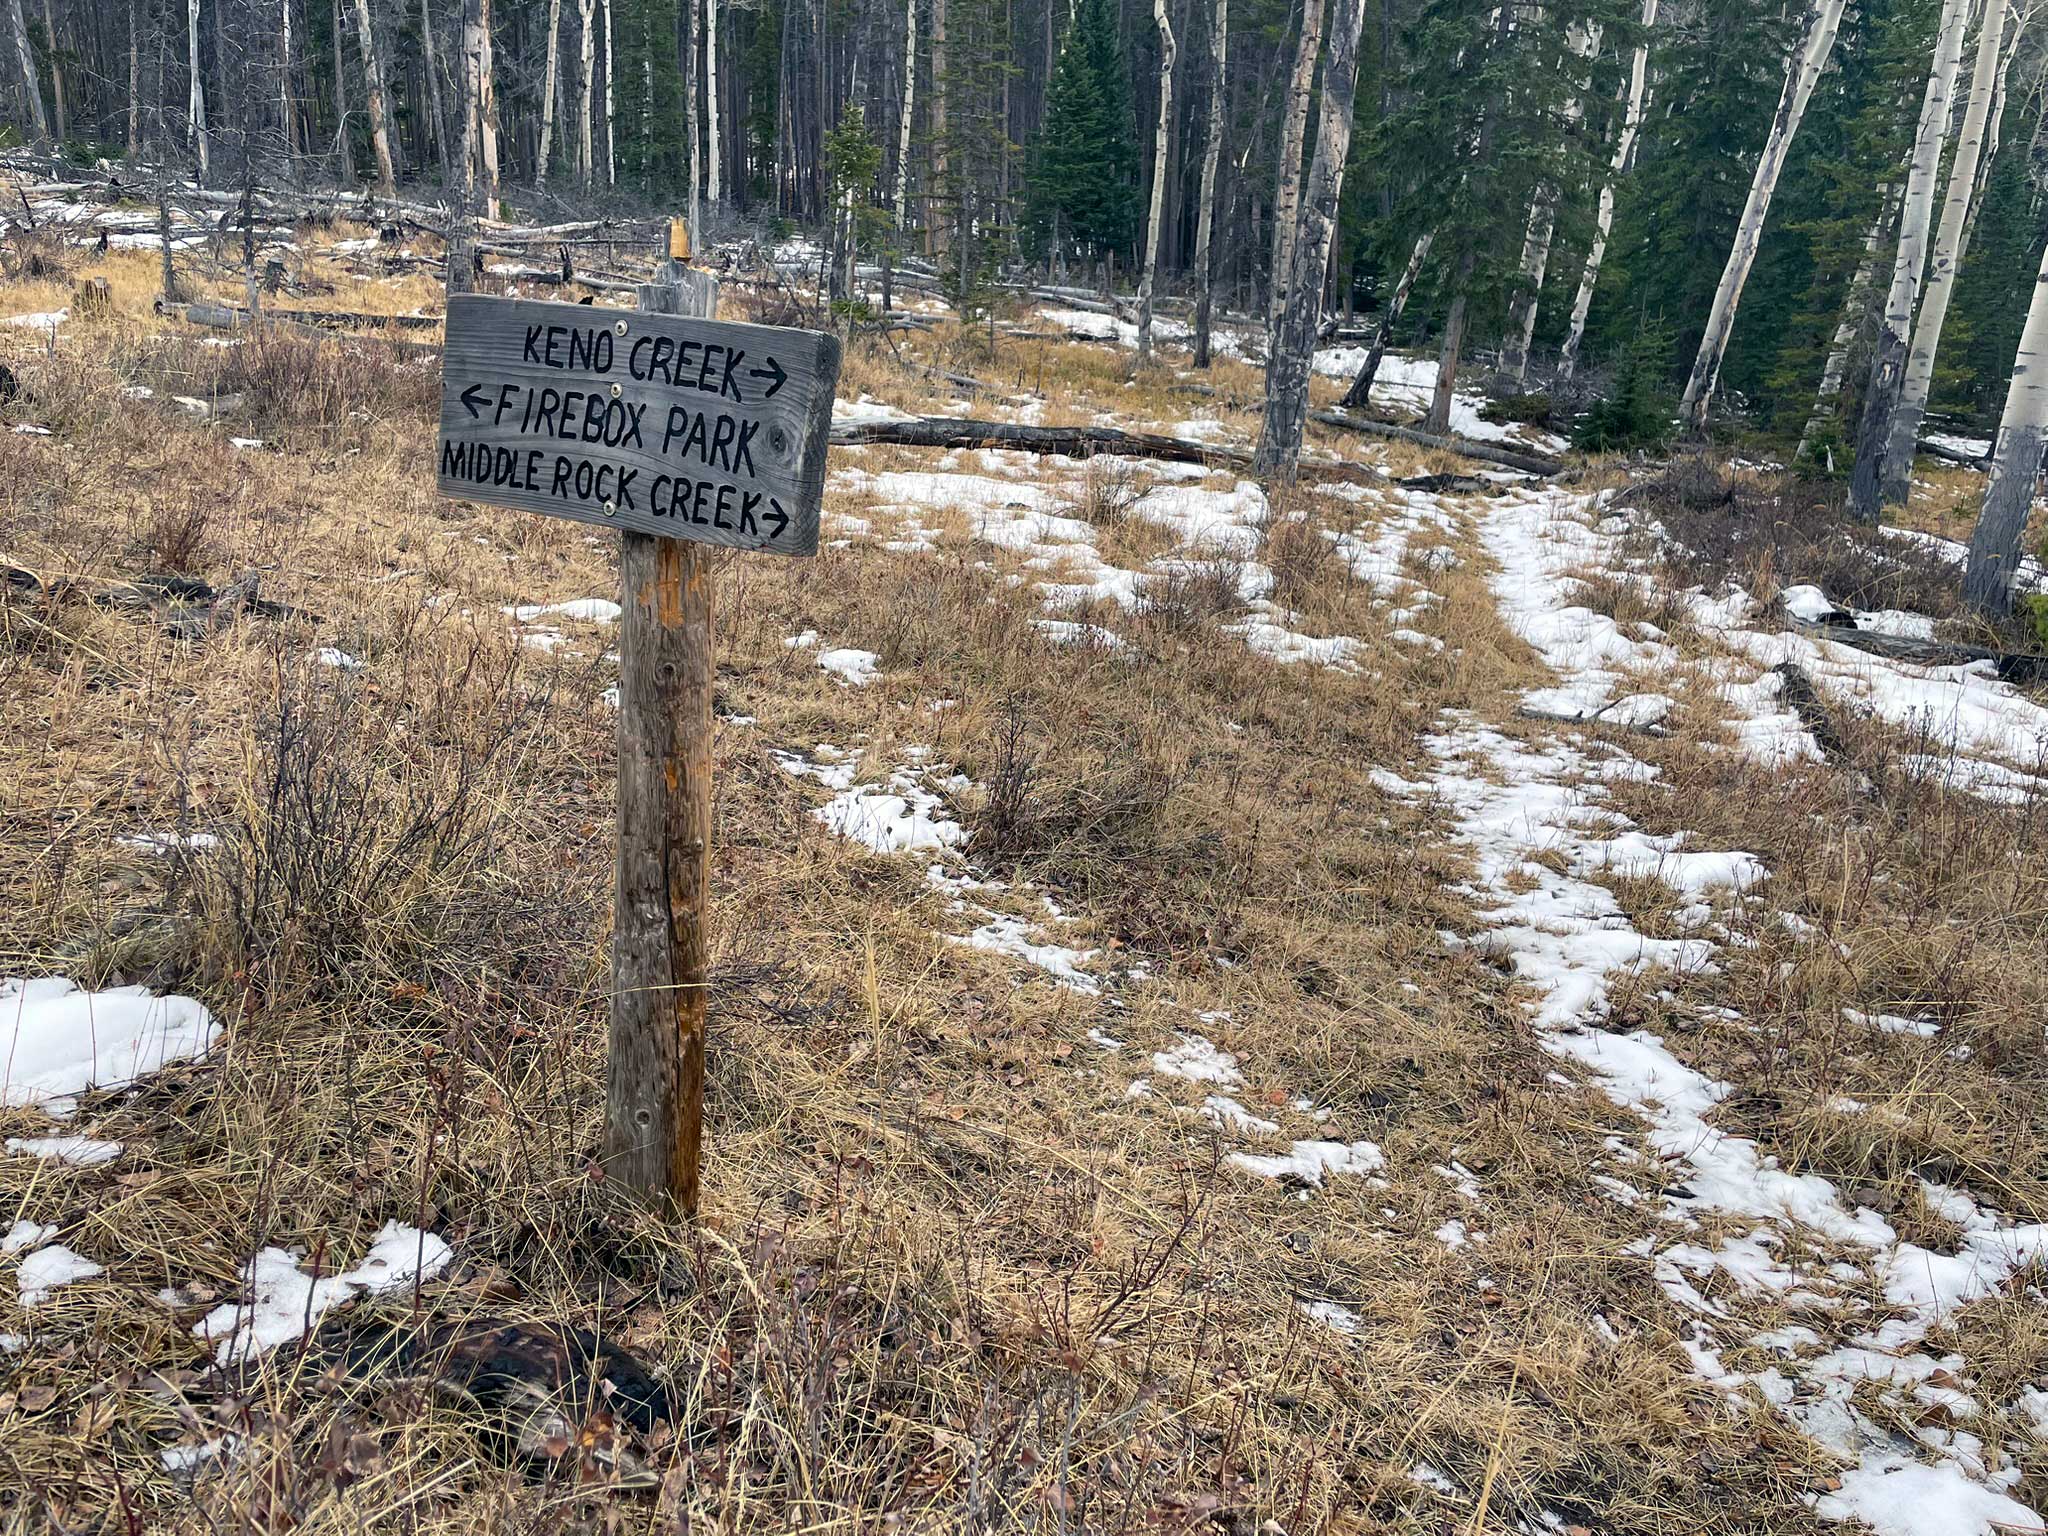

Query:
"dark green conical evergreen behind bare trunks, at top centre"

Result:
[[1026, 0, 1139, 256]]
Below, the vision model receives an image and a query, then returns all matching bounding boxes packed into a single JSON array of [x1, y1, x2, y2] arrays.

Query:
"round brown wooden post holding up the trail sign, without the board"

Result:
[[604, 262, 719, 1217]]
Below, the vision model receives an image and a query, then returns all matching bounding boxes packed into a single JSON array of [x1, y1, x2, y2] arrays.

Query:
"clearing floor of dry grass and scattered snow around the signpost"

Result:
[[0, 229, 2048, 1536]]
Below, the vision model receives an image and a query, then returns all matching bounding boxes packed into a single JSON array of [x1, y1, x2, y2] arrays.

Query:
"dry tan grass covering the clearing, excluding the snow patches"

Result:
[[0, 243, 2048, 1536]]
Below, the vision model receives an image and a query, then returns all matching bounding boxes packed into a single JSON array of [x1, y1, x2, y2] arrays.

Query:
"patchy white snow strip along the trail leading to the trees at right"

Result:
[[1378, 489, 2048, 1536]]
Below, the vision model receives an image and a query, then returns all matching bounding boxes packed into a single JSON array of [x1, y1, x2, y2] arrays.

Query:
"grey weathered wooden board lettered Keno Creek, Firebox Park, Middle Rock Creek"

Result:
[[436, 295, 840, 555]]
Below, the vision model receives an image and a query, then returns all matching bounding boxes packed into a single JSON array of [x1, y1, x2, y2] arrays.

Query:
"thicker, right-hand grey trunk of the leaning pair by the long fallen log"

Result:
[[1253, 0, 1366, 481]]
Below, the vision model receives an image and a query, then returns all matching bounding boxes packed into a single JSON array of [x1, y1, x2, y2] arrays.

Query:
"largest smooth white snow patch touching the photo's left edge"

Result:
[[0, 977, 221, 1116]]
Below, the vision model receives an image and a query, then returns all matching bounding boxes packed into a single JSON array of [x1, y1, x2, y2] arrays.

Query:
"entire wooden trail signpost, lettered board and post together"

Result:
[[436, 262, 840, 1214]]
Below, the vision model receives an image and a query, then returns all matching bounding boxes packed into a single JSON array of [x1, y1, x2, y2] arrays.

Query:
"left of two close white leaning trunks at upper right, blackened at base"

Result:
[[1849, 0, 1966, 522]]
